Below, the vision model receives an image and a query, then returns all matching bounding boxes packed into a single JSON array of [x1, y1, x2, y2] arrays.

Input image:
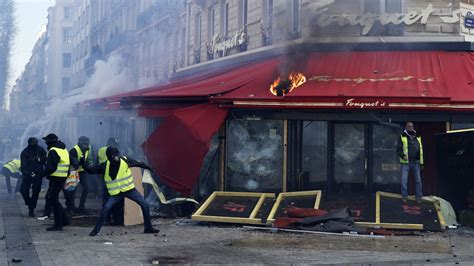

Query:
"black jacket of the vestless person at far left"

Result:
[[20, 145, 46, 178]]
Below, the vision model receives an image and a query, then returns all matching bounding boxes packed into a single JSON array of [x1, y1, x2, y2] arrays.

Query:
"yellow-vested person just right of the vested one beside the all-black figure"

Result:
[[64, 136, 92, 214]]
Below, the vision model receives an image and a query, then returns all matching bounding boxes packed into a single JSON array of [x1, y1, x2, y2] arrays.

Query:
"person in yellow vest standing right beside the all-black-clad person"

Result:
[[43, 134, 70, 231]]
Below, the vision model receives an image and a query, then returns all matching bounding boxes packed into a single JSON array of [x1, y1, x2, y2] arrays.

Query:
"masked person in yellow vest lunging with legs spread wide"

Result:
[[85, 147, 160, 236]]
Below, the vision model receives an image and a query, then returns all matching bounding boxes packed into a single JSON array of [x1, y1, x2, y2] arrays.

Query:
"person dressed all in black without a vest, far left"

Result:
[[20, 138, 46, 217]]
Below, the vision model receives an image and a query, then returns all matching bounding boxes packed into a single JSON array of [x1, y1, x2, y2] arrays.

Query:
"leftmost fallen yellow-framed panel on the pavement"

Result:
[[192, 191, 275, 224]]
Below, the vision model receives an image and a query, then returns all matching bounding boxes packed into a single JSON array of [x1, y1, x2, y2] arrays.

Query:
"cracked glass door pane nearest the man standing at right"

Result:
[[331, 123, 367, 193]]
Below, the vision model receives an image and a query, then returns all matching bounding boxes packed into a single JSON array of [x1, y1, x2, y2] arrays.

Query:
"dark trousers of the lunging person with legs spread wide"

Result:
[[94, 189, 152, 232]]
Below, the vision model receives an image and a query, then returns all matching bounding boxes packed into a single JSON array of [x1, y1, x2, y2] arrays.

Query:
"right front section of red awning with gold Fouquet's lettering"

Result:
[[213, 51, 474, 109]]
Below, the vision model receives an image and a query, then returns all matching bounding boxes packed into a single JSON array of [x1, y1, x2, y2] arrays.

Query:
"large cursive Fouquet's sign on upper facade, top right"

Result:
[[316, 1, 462, 35]]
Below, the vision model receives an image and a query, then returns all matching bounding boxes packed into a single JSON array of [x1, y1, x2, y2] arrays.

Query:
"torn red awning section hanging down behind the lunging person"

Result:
[[142, 104, 228, 196]]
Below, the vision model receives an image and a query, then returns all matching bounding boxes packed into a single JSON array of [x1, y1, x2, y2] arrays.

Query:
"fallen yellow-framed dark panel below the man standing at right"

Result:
[[376, 192, 445, 231]]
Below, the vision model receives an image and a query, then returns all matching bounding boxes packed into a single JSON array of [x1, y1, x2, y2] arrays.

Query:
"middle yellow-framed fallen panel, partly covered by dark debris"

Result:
[[267, 190, 322, 223]]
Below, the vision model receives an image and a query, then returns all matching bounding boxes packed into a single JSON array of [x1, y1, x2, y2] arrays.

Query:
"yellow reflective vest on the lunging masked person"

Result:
[[104, 159, 135, 196]]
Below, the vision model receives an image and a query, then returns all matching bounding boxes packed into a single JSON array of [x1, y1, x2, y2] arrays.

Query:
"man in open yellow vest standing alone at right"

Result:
[[397, 122, 424, 203]]
